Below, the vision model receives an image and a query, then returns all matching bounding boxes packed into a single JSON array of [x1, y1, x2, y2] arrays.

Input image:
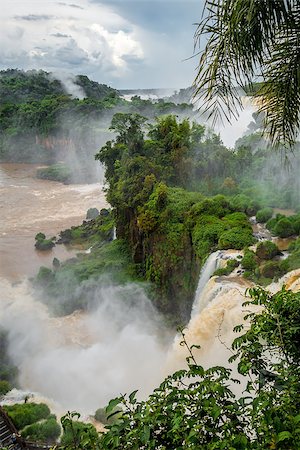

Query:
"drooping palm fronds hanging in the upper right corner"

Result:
[[194, 0, 300, 145]]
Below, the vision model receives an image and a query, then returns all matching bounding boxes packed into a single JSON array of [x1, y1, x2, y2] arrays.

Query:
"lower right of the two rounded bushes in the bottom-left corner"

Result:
[[21, 417, 61, 443]]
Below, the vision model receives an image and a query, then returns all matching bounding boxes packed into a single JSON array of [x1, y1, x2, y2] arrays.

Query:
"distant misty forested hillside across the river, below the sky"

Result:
[[0, 70, 193, 182]]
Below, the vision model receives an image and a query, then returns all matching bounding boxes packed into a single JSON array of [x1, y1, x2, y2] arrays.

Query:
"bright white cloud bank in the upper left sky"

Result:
[[0, 0, 144, 78]]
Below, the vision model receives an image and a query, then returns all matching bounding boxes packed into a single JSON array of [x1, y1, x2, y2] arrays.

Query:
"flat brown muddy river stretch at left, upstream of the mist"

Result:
[[0, 164, 107, 281]]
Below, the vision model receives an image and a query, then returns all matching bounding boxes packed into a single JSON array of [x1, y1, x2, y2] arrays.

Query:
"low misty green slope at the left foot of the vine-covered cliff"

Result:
[[35, 209, 146, 315]]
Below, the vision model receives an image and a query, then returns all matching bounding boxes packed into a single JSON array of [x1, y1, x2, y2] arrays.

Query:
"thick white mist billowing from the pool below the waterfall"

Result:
[[0, 279, 170, 414]]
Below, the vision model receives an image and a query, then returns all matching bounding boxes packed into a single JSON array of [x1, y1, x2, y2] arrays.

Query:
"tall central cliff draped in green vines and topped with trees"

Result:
[[96, 113, 255, 322]]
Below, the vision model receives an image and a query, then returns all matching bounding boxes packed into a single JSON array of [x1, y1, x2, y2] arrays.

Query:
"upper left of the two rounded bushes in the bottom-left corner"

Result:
[[4, 403, 50, 430]]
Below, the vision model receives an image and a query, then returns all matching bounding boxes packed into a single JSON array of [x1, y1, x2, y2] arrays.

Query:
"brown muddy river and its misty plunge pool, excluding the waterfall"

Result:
[[0, 164, 166, 414]]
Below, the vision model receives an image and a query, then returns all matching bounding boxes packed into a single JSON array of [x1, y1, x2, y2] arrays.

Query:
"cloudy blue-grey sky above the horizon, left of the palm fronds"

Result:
[[0, 0, 203, 89]]
